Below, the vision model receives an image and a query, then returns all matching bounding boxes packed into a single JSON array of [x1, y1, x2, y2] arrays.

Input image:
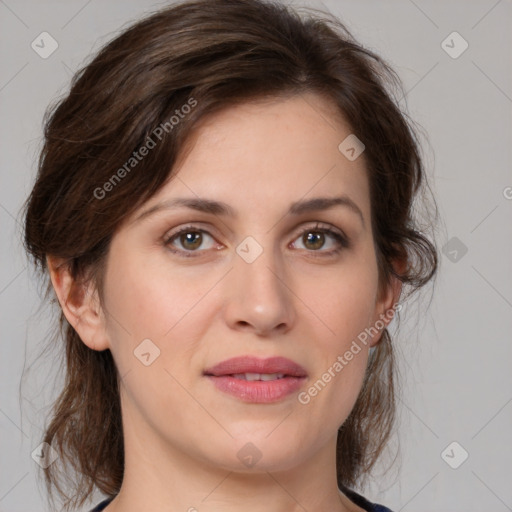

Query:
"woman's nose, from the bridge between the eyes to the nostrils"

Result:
[[226, 237, 294, 333]]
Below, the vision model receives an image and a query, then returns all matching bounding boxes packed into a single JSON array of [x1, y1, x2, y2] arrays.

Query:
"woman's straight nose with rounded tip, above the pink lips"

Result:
[[224, 243, 296, 336]]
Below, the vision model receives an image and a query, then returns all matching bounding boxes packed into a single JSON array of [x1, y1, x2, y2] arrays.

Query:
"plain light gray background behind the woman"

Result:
[[0, 0, 512, 512]]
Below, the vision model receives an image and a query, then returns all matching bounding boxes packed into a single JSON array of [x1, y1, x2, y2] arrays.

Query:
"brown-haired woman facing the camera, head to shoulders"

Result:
[[25, 0, 437, 512]]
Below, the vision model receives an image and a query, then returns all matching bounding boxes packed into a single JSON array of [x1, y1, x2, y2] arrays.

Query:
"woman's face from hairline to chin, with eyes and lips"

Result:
[[85, 94, 393, 471]]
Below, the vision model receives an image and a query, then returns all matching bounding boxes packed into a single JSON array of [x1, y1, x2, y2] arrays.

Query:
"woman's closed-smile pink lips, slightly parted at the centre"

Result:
[[203, 356, 307, 403]]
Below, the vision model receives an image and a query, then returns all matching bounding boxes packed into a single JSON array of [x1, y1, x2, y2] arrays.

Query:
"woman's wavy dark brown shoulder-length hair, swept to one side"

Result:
[[20, 0, 438, 506]]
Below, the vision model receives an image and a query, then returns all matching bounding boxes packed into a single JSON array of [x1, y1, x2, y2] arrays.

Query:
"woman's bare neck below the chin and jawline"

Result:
[[105, 404, 362, 512]]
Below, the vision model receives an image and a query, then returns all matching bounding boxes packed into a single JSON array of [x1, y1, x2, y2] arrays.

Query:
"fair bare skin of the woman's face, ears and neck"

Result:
[[48, 93, 400, 512]]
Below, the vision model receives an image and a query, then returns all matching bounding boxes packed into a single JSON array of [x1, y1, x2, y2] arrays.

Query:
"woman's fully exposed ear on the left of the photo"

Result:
[[46, 256, 110, 351]]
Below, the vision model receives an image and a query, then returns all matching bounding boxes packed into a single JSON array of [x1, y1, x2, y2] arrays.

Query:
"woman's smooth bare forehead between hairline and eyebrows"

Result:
[[130, 93, 370, 224]]
